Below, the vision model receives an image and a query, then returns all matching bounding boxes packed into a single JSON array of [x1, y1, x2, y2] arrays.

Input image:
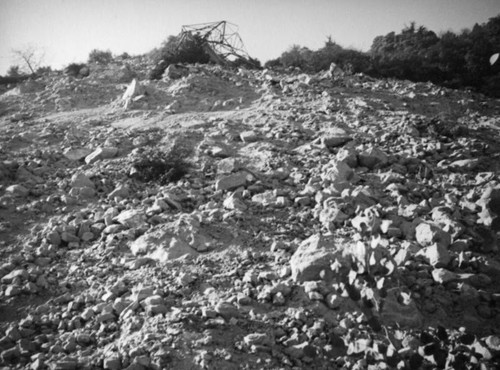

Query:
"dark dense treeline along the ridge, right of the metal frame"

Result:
[[265, 15, 500, 96]]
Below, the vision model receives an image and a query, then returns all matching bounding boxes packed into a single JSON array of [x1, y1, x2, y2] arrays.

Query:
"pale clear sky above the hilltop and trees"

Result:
[[0, 0, 500, 74]]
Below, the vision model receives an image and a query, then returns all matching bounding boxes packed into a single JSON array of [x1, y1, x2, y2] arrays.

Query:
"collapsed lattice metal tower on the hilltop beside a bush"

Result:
[[179, 21, 255, 65]]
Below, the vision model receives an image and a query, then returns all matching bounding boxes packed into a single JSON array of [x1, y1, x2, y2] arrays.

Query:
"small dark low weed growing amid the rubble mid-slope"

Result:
[[130, 146, 190, 185]]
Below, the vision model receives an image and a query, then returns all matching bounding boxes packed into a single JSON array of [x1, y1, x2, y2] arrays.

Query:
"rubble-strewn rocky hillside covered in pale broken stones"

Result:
[[0, 65, 500, 370]]
